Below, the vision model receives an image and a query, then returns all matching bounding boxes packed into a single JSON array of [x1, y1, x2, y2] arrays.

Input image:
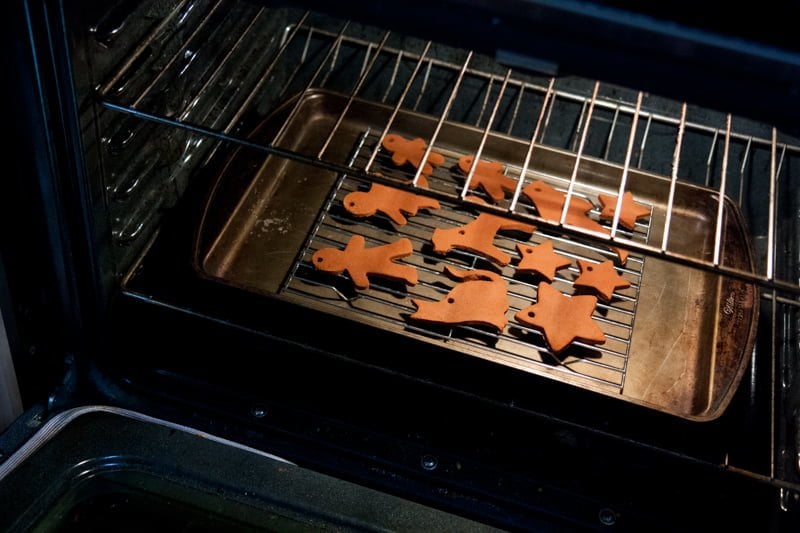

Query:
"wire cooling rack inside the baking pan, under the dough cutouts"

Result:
[[282, 132, 649, 392]]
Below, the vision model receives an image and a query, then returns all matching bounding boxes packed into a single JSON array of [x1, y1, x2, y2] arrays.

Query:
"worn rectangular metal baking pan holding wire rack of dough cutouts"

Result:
[[197, 91, 757, 420]]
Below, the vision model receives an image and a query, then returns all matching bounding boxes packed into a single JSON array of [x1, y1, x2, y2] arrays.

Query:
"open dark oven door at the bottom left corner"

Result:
[[0, 406, 494, 532]]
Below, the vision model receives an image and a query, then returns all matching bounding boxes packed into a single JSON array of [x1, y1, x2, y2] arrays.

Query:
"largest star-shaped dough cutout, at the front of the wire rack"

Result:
[[514, 282, 606, 353]]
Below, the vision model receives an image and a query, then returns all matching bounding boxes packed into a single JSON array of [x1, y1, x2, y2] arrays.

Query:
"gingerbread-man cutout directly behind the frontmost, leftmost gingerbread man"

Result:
[[342, 183, 440, 226]]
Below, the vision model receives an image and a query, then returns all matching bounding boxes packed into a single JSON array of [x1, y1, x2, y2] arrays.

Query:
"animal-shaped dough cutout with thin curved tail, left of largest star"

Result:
[[411, 266, 508, 331]]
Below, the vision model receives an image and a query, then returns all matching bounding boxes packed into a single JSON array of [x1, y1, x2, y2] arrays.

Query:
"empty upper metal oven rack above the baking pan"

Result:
[[99, 2, 800, 305]]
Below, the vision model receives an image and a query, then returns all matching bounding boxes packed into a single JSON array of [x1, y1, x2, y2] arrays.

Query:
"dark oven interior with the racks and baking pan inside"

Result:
[[9, 0, 800, 522]]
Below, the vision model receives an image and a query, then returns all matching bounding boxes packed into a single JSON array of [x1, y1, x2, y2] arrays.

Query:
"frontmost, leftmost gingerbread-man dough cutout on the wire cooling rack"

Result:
[[311, 235, 417, 289]]
